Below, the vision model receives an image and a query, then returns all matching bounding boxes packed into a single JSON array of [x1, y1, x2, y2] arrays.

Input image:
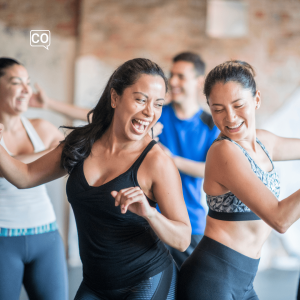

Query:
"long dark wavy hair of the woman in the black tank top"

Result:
[[60, 58, 168, 174]]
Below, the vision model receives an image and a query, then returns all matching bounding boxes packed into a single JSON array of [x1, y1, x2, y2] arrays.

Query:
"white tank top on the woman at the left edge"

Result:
[[0, 117, 55, 228]]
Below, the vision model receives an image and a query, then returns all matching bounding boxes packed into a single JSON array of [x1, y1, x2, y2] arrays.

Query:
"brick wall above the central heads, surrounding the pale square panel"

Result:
[[79, 0, 300, 121]]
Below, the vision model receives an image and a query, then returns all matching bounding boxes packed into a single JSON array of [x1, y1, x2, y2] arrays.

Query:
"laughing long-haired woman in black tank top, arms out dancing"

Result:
[[0, 59, 191, 300]]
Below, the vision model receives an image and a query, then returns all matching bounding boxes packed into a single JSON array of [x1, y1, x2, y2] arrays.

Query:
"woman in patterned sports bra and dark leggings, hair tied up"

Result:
[[178, 61, 300, 300]]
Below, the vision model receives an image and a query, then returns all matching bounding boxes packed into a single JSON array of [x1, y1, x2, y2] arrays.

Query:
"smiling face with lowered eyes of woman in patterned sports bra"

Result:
[[208, 81, 260, 141]]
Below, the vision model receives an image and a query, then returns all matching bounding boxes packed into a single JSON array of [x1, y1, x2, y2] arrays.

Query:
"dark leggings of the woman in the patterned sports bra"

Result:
[[177, 236, 259, 300]]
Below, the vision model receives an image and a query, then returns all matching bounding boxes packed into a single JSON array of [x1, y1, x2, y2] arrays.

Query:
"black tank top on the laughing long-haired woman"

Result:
[[67, 141, 172, 291]]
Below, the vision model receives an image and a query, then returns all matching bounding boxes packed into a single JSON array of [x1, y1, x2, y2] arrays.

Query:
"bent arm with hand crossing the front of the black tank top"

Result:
[[112, 145, 191, 251]]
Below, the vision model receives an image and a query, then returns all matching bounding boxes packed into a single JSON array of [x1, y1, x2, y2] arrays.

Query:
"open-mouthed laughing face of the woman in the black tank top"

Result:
[[111, 74, 166, 140]]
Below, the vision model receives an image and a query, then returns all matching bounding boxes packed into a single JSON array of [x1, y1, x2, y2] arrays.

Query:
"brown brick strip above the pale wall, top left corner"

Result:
[[0, 0, 79, 36]]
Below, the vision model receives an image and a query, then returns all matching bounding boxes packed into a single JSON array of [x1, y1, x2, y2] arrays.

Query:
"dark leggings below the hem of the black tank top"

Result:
[[74, 263, 178, 300]]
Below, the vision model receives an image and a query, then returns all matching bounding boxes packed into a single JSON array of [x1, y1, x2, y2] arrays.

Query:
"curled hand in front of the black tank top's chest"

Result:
[[111, 186, 154, 218]]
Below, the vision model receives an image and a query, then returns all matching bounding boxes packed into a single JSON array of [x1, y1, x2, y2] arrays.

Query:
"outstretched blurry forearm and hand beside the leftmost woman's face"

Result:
[[29, 84, 90, 121]]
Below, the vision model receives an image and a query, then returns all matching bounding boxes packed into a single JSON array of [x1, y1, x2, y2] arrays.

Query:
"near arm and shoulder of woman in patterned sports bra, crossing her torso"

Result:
[[204, 141, 300, 233]]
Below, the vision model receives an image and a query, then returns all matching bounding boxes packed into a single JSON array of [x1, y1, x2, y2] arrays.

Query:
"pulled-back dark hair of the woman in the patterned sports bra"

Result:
[[204, 60, 256, 103]]
